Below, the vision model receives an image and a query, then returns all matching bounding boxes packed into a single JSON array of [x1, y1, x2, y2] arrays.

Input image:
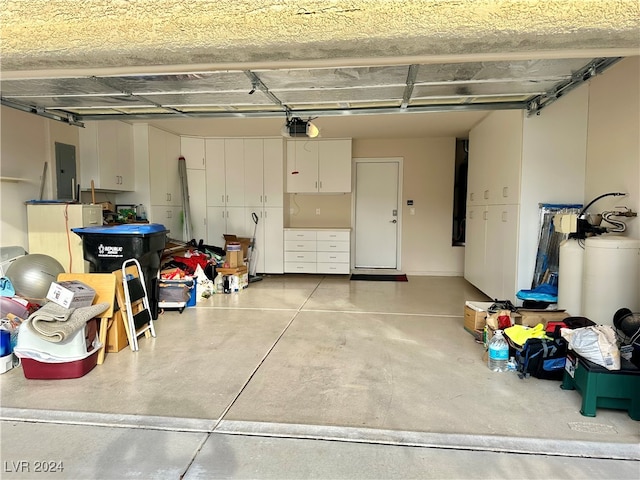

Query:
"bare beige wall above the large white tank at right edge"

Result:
[[584, 57, 640, 239]]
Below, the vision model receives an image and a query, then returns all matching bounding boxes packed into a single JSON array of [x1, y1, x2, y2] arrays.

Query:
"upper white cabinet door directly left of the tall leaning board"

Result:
[[149, 126, 182, 206]]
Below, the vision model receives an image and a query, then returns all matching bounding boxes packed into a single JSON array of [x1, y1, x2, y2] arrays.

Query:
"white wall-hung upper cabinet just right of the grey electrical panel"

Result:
[[79, 120, 135, 191]]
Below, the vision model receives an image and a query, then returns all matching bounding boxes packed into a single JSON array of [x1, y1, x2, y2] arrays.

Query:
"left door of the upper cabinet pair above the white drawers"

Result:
[[287, 140, 318, 193]]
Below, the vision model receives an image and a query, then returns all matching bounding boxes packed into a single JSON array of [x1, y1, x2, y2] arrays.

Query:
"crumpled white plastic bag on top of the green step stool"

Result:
[[560, 325, 620, 370]]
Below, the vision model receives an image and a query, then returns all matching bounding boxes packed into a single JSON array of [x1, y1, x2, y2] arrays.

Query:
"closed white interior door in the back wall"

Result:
[[354, 158, 401, 269]]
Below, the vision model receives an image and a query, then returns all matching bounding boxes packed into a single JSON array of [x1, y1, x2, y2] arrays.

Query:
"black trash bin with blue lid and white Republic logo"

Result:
[[71, 223, 168, 319]]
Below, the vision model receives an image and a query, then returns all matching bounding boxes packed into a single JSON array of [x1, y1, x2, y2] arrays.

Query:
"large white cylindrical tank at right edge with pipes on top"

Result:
[[582, 235, 640, 326]]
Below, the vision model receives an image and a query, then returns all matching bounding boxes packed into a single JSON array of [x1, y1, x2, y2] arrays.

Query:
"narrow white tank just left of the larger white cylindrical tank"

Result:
[[558, 238, 584, 317]]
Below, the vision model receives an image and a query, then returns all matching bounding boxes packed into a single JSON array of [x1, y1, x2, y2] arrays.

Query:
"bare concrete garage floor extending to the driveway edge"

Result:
[[0, 275, 640, 479]]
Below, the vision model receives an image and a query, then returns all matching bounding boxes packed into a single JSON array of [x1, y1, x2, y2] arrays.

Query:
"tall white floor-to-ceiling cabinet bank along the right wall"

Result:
[[464, 111, 524, 303]]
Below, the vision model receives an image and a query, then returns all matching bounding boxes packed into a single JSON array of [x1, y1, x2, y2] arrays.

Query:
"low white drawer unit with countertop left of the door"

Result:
[[284, 229, 351, 274]]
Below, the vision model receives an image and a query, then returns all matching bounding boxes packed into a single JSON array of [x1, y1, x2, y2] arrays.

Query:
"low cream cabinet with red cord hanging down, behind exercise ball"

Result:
[[27, 204, 102, 273]]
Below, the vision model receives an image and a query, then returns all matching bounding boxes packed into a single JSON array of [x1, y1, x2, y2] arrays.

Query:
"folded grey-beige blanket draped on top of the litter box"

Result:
[[27, 302, 109, 343]]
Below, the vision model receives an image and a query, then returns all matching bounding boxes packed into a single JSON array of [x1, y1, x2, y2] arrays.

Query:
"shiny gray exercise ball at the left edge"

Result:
[[6, 253, 64, 300]]
